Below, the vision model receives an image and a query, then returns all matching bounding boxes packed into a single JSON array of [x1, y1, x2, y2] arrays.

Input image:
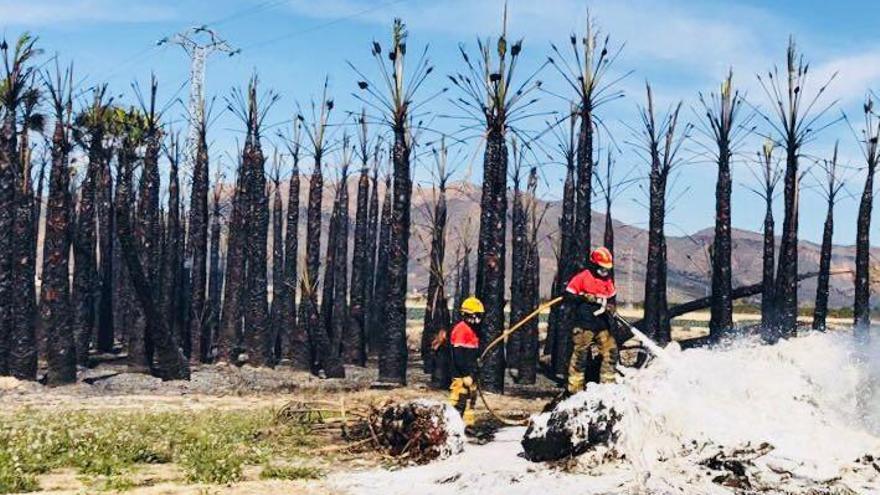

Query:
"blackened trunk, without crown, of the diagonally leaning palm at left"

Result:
[[115, 128, 190, 380]]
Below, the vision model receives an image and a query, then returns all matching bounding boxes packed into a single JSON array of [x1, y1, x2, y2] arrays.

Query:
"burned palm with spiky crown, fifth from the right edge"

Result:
[[697, 71, 752, 341]]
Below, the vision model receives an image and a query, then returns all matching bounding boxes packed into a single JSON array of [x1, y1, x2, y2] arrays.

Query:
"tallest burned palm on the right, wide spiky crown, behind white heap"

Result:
[[758, 38, 836, 341]]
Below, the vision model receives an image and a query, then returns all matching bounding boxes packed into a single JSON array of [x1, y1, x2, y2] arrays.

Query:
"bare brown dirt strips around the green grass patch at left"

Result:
[[0, 356, 555, 495]]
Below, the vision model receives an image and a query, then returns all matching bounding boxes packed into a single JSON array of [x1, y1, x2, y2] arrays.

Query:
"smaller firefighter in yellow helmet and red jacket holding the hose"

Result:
[[449, 297, 485, 426]]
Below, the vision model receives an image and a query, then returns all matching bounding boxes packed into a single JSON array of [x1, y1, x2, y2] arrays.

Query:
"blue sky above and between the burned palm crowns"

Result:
[[0, 0, 880, 245]]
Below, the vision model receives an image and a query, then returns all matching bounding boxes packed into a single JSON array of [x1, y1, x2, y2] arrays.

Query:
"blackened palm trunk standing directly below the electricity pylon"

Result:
[[187, 120, 211, 363]]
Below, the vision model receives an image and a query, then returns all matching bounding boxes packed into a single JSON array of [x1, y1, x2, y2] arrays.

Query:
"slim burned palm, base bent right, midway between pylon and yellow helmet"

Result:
[[295, 85, 345, 376]]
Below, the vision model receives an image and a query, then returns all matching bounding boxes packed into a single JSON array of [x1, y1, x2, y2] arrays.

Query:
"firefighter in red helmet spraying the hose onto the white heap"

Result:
[[564, 247, 618, 394]]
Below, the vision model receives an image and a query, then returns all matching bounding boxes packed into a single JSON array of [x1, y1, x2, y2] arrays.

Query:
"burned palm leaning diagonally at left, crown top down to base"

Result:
[[114, 111, 190, 380]]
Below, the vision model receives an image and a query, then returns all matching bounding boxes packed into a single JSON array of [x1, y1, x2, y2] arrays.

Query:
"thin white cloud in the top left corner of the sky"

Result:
[[0, 0, 174, 26]]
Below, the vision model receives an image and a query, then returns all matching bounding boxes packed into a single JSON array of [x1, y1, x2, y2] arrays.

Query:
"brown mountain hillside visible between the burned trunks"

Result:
[[262, 176, 880, 307]]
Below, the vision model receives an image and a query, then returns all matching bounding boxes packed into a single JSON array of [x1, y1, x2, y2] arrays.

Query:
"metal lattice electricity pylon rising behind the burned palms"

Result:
[[157, 26, 235, 174]]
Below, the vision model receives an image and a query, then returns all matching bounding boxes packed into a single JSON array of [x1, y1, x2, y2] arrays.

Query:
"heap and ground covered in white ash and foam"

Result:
[[331, 333, 880, 495]]
